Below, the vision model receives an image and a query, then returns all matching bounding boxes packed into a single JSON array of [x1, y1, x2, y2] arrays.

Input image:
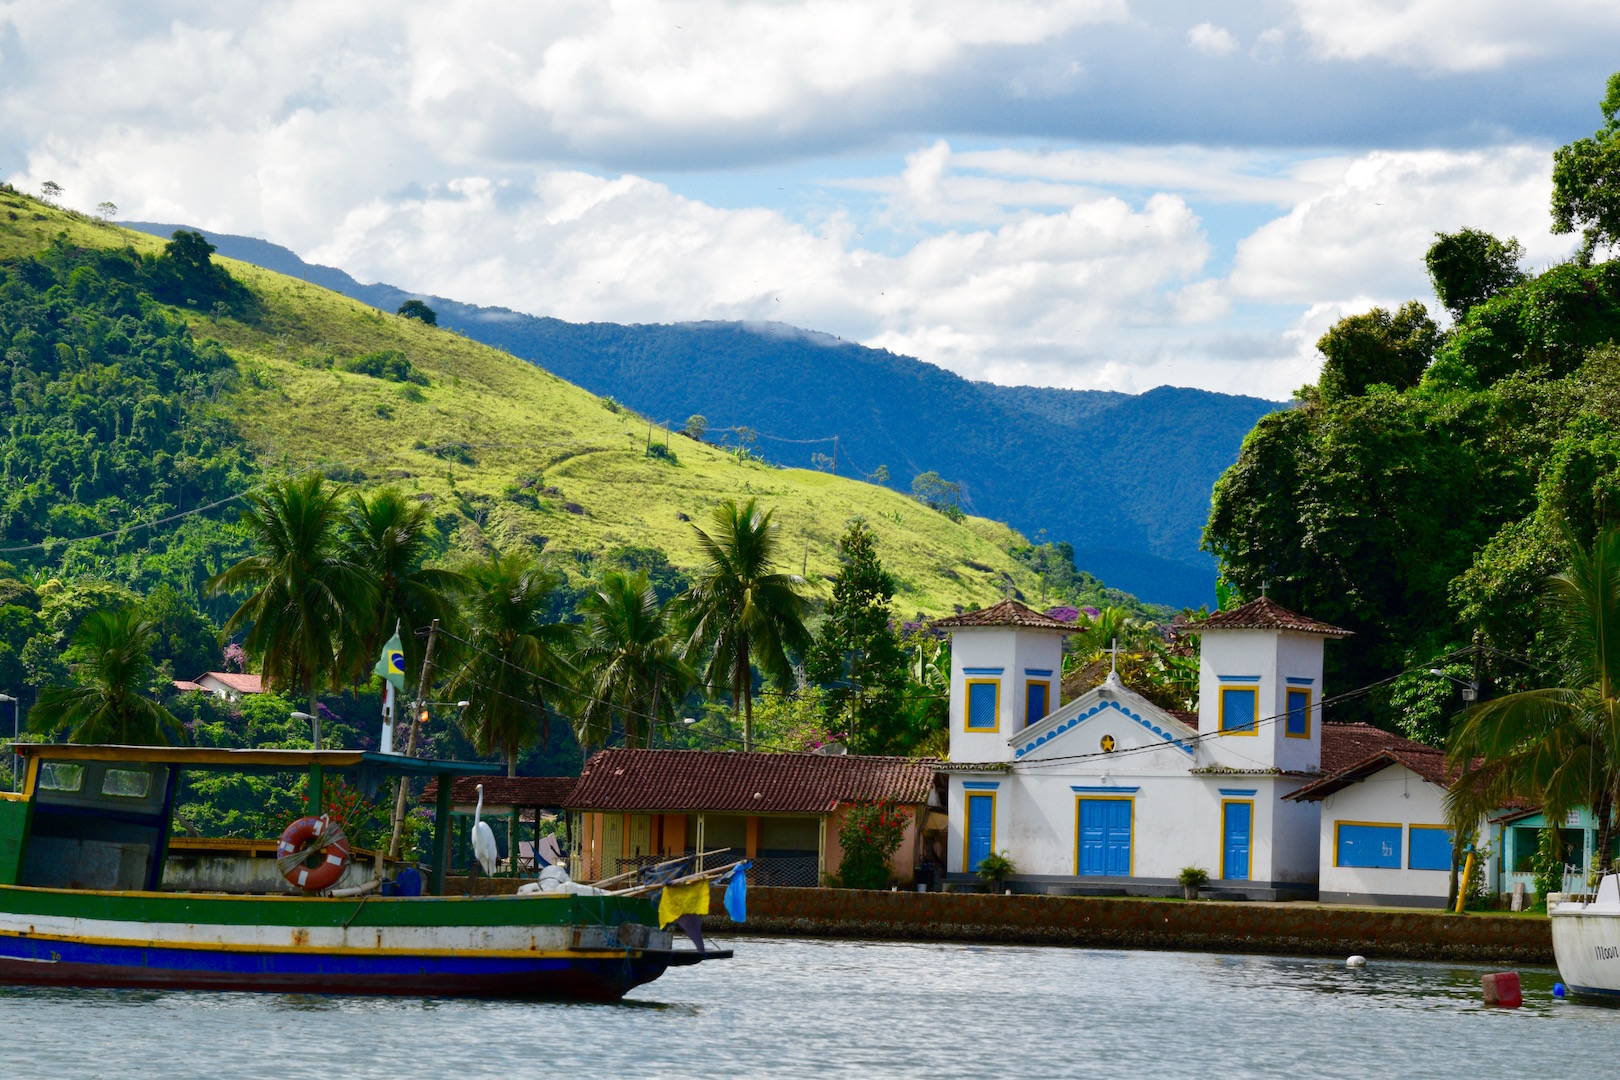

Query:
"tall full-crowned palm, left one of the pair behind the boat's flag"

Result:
[[207, 473, 377, 750]]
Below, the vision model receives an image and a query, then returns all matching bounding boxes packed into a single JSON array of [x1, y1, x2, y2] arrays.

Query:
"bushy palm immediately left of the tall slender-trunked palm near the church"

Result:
[[575, 570, 697, 748]]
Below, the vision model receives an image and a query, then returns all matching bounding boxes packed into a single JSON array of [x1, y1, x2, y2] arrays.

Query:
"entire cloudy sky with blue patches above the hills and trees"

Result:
[[0, 0, 1620, 398]]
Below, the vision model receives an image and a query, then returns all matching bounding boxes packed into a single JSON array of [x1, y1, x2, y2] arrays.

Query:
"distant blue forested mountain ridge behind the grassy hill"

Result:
[[131, 222, 1280, 606]]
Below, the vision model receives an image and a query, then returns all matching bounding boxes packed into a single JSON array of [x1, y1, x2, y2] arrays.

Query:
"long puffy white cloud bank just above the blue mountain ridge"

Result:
[[306, 158, 1209, 395]]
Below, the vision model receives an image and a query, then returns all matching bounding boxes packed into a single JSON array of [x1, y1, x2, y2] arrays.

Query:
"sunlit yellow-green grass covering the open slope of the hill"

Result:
[[0, 198, 1040, 617]]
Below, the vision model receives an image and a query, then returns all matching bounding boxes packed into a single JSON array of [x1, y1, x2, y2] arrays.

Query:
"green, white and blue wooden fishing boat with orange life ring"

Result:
[[0, 743, 731, 1001]]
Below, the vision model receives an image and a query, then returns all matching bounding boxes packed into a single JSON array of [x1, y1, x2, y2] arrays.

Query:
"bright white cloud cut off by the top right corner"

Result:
[[1291, 0, 1620, 71]]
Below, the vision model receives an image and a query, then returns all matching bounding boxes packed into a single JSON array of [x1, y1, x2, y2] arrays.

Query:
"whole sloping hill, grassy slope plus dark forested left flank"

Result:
[[0, 196, 1162, 786]]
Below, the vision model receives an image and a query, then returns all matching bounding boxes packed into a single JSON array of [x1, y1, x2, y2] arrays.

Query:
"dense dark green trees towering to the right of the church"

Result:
[[1209, 76, 1620, 742]]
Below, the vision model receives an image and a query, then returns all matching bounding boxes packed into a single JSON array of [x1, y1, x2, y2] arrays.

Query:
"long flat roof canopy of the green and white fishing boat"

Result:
[[11, 743, 505, 776]]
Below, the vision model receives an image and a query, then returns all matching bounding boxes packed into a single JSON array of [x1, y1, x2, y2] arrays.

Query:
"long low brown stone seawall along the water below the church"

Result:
[[705, 887, 1554, 963]]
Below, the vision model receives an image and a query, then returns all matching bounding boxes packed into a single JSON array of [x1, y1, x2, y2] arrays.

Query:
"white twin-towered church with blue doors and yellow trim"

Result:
[[935, 597, 1373, 900]]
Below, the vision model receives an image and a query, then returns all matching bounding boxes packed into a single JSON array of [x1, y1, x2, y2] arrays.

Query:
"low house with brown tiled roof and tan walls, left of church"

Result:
[[567, 750, 940, 886]]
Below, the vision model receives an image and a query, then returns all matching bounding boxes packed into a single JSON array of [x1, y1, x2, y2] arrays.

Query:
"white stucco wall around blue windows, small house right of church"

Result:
[[1319, 764, 1450, 904]]
